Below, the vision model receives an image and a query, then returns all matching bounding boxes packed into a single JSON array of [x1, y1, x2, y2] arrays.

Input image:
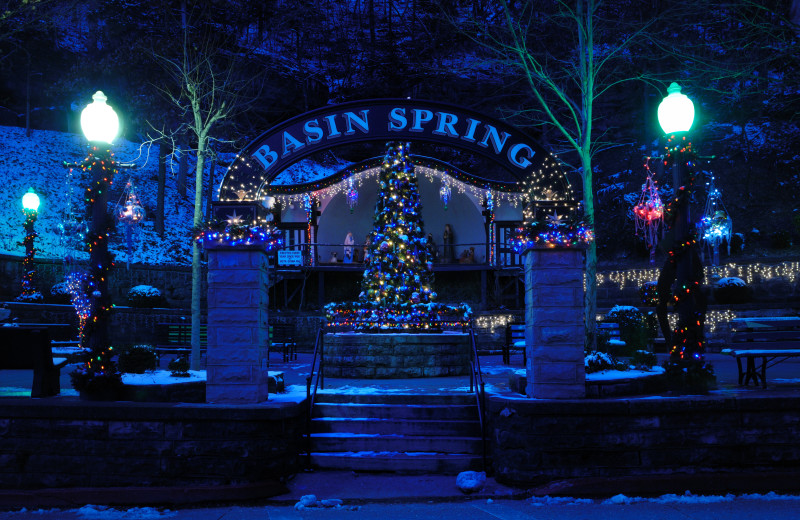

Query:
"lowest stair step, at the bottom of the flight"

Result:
[[311, 451, 483, 475]]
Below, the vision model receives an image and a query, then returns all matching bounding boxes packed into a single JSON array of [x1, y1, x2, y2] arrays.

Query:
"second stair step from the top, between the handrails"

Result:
[[314, 403, 478, 420]]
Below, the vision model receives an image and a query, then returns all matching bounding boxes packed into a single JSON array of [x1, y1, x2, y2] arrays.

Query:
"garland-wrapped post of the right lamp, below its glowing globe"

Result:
[[657, 134, 706, 373]]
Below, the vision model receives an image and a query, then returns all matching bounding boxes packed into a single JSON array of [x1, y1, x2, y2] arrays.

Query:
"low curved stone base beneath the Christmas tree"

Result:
[[324, 332, 471, 379]]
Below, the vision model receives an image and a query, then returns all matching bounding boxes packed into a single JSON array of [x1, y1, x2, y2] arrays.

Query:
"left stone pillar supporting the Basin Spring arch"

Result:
[[206, 245, 269, 404]]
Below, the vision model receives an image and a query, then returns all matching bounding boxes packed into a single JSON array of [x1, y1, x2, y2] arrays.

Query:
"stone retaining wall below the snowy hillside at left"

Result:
[[0, 255, 207, 309]]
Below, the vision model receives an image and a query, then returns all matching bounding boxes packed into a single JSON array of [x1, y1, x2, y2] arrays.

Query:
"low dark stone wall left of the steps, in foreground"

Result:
[[0, 399, 306, 489]]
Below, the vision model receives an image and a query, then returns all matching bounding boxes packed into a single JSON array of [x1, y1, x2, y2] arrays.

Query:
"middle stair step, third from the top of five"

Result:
[[311, 417, 481, 437]]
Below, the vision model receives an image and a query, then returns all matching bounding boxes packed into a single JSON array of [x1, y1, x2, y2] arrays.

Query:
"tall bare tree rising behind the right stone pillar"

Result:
[[456, 0, 651, 345]]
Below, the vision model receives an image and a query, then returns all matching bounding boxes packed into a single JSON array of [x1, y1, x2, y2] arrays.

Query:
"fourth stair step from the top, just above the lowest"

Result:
[[311, 433, 483, 453]]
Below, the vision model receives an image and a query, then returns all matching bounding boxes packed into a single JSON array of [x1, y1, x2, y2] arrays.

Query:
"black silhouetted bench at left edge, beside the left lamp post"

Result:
[[0, 324, 67, 397]]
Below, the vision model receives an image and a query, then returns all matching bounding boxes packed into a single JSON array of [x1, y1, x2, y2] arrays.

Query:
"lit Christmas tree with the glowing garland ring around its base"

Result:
[[326, 142, 470, 332]]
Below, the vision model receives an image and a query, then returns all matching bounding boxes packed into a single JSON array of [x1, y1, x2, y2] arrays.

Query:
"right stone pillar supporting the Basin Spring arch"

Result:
[[524, 249, 586, 399]]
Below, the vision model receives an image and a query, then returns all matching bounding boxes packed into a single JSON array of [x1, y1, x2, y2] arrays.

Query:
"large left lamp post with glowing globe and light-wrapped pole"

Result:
[[81, 90, 119, 357]]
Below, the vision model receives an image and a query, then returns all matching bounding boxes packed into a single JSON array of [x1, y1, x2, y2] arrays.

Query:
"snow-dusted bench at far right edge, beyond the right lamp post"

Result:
[[722, 317, 800, 388]]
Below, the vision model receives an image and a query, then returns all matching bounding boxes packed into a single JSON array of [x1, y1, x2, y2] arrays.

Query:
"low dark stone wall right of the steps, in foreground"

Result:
[[487, 395, 800, 485]]
